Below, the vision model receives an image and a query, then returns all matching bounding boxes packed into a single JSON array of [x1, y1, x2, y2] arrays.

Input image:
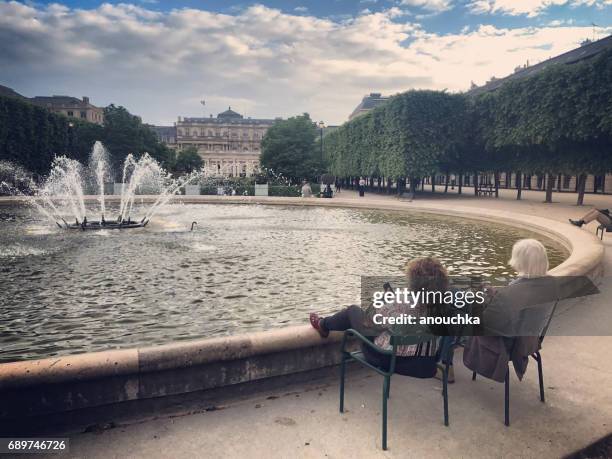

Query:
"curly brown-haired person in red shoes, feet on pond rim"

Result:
[[310, 258, 449, 378]]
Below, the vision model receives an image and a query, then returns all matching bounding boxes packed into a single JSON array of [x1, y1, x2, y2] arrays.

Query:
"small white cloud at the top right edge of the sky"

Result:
[[474, 0, 612, 17]]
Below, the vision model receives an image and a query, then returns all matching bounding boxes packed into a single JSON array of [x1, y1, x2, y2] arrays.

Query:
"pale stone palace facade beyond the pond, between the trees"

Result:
[[170, 107, 280, 177]]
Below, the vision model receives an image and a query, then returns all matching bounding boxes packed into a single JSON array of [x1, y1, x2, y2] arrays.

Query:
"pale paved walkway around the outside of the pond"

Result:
[[71, 189, 612, 458]]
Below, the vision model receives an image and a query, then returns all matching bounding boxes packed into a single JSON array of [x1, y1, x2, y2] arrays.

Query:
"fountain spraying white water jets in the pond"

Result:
[[2, 142, 202, 231]]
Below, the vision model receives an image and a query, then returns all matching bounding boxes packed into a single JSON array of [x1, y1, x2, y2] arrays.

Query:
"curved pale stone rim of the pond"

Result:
[[0, 195, 604, 430]]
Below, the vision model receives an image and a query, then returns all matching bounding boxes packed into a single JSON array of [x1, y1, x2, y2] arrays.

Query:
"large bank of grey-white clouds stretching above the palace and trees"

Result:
[[0, 2, 612, 124]]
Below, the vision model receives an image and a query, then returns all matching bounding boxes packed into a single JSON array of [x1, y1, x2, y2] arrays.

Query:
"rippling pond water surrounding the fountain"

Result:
[[0, 204, 564, 362]]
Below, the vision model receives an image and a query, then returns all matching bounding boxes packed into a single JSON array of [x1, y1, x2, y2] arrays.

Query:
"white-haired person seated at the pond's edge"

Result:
[[463, 239, 554, 382]]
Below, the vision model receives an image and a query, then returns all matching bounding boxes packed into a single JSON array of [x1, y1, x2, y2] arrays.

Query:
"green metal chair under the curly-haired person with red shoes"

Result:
[[340, 329, 452, 450]]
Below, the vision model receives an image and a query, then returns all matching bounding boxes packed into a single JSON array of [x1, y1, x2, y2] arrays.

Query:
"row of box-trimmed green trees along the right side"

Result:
[[325, 51, 612, 204]]
